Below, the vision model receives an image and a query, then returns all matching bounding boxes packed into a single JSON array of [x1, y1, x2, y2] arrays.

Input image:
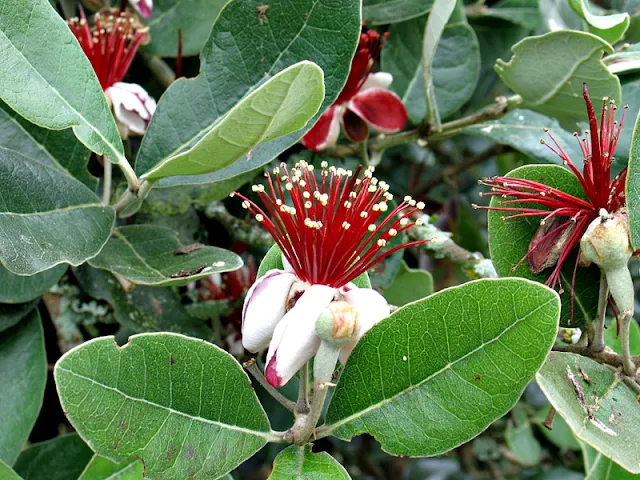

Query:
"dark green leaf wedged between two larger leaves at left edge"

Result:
[[0, 100, 98, 190]]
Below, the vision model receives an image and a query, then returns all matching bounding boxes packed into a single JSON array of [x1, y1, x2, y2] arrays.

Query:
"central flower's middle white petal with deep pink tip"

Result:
[[265, 285, 336, 387]]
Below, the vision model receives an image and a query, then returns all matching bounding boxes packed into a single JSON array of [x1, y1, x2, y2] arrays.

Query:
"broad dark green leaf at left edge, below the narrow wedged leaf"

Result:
[[0, 148, 115, 275]]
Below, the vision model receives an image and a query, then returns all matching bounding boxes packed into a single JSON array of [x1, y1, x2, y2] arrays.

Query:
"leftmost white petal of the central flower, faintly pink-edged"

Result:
[[242, 269, 296, 353]]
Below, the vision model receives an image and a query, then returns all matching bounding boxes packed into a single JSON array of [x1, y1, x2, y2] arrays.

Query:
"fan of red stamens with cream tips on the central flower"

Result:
[[231, 161, 426, 288]]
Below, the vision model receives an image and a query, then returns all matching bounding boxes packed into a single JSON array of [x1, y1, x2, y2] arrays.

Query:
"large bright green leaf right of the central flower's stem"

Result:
[[326, 279, 560, 456]]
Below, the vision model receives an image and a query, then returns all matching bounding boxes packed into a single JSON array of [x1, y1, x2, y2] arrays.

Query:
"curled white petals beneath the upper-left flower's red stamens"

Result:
[[104, 82, 156, 137]]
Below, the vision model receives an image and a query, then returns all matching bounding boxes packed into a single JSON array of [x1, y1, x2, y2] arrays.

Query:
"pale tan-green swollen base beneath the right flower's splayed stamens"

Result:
[[580, 209, 633, 271]]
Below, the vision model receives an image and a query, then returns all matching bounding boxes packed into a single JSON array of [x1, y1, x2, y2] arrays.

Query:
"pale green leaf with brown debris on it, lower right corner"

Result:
[[536, 352, 640, 473]]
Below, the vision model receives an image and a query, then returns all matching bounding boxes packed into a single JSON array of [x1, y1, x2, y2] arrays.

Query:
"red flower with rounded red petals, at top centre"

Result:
[[302, 30, 407, 151]]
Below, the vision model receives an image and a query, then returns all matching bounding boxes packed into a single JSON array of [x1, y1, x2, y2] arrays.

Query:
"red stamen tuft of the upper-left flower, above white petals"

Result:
[[67, 9, 149, 90]]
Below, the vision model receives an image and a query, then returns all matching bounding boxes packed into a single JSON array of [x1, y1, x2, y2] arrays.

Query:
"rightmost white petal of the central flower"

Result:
[[339, 284, 389, 365]]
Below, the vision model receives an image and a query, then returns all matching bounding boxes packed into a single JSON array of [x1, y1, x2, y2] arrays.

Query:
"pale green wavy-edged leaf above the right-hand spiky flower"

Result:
[[496, 31, 620, 129]]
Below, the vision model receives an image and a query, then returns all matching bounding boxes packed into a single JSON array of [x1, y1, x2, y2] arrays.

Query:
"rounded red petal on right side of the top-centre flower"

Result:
[[349, 88, 407, 133]]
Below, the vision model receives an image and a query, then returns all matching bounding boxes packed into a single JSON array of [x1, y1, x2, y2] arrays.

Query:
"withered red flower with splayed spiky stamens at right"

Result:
[[474, 84, 627, 293]]
